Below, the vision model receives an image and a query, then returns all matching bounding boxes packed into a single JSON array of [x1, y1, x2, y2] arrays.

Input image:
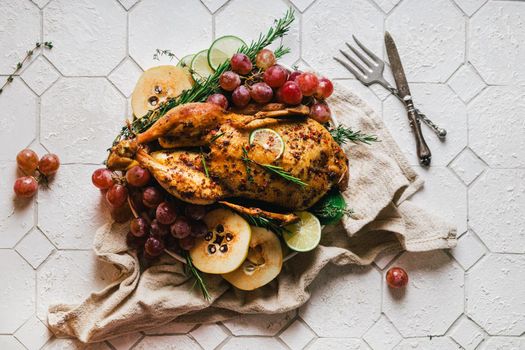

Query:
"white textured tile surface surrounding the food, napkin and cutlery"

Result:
[[0, 0, 525, 350]]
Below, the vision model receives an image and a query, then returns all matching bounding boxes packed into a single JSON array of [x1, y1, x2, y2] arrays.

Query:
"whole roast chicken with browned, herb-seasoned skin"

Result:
[[109, 103, 348, 210]]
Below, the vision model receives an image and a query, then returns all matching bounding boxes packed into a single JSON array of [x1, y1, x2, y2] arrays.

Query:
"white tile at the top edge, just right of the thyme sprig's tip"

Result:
[[44, 0, 126, 76]]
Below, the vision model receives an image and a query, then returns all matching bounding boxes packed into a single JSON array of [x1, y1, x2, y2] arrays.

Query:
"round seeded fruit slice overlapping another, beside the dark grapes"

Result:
[[190, 208, 252, 274]]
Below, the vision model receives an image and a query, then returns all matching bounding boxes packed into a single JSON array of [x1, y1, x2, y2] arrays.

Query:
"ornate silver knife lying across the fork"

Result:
[[385, 32, 432, 166]]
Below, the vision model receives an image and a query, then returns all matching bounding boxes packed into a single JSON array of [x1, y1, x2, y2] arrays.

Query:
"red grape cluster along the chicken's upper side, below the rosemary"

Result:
[[207, 49, 334, 123]]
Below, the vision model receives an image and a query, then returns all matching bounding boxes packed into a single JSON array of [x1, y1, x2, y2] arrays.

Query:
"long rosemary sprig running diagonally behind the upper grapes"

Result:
[[114, 8, 295, 144]]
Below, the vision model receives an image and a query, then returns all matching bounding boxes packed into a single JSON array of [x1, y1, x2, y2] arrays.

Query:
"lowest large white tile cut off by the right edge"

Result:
[[466, 254, 525, 335]]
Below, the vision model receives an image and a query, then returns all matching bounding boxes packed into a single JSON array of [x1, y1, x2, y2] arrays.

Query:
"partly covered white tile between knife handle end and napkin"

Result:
[[411, 167, 467, 234]]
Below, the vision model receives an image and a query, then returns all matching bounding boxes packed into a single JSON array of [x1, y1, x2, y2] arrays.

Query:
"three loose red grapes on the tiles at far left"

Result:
[[13, 148, 60, 198]]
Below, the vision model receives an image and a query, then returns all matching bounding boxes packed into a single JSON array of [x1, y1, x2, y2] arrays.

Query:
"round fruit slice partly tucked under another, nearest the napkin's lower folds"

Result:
[[222, 227, 283, 290]]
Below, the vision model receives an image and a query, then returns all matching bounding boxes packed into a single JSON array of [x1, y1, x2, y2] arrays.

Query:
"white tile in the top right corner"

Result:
[[469, 1, 525, 84]]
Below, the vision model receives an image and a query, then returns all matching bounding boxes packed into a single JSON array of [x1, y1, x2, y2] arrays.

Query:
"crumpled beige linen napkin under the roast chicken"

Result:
[[48, 85, 456, 342]]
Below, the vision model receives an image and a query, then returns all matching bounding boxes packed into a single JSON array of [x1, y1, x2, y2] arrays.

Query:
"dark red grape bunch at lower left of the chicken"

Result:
[[92, 165, 208, 259]]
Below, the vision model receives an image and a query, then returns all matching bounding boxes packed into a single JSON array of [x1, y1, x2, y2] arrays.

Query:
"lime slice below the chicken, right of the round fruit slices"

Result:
[[283, 211, 321, 252]]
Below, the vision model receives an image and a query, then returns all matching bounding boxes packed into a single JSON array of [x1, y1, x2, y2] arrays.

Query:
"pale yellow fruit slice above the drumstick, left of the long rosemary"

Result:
[[131, 65, 193, 118]]
